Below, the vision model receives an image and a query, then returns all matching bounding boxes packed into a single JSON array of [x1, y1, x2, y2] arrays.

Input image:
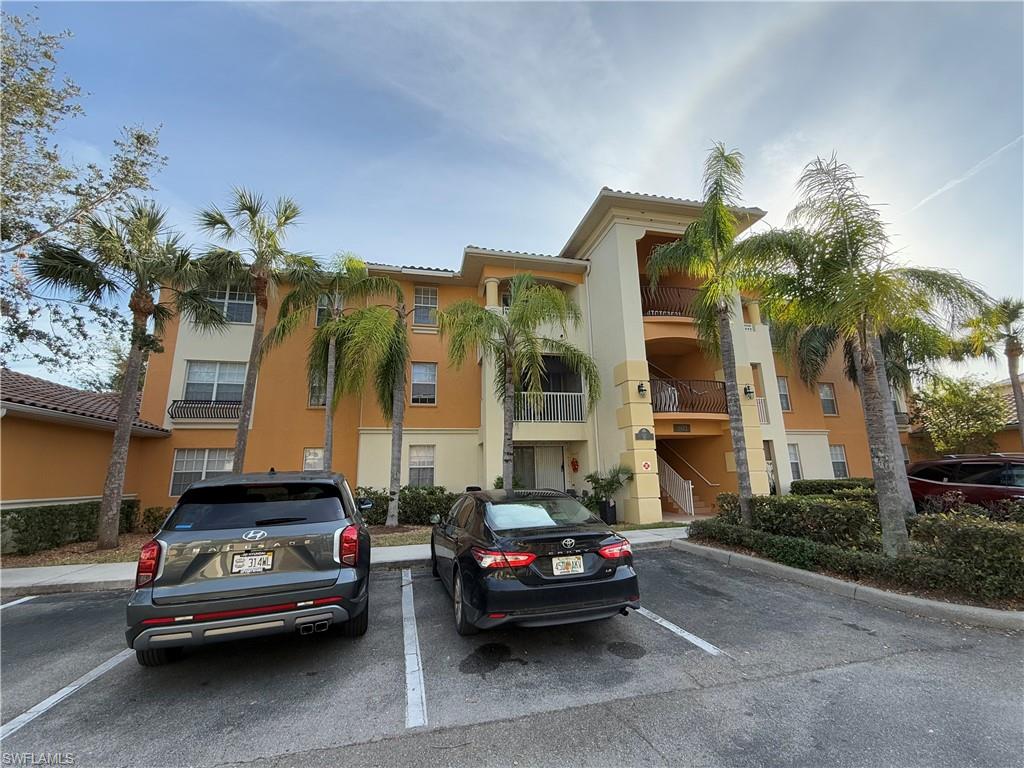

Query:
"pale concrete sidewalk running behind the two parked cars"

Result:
[[0, 526, 689, 599]]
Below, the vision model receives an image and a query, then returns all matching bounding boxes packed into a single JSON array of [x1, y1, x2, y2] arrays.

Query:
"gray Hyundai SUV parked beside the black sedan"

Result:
[[125, 470, 370, 667]]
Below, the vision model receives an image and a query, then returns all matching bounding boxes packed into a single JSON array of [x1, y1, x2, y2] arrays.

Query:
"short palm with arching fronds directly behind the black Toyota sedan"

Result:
[[437, 273, 601, 488]]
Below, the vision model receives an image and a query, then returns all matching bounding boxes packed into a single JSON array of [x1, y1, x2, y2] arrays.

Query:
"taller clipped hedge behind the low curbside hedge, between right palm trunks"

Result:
[[718, 494, 882, 550]]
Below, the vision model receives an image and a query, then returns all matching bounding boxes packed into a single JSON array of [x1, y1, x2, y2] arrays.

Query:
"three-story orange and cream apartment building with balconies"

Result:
[[4, 188, 870, 522]]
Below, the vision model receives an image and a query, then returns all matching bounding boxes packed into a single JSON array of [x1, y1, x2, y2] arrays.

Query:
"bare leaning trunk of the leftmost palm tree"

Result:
[[96, 309, 153, 549]]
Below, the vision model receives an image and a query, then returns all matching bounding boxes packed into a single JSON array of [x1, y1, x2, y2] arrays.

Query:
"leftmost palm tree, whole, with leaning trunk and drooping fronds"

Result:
[[30, 200, 224, 549]]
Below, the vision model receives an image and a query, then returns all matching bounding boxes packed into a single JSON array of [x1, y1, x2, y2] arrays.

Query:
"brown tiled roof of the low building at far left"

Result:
[[0, 368, 170, 435]]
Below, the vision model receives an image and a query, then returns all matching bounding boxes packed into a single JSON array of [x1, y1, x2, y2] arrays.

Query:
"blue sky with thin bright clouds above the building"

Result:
[[4, 2, 1024, 379]]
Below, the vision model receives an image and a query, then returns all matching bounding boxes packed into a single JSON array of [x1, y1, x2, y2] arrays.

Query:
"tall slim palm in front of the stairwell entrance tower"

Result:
[[647, 142, 754, 525]]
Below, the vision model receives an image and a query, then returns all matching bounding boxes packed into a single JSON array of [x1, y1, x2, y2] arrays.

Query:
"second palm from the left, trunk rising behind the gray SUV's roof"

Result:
[[198, 187, 317, 472]]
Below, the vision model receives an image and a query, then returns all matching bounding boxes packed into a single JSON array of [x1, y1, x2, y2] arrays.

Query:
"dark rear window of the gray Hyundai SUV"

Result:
[[164, 482, 346, 530]]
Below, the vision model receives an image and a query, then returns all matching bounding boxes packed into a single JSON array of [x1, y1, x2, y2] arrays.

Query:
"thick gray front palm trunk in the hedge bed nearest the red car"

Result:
[[854, 339, 913, 557]]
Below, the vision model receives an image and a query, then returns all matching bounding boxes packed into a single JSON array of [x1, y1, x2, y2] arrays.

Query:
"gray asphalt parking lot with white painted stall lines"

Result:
[[0, 550, 1024, 766]]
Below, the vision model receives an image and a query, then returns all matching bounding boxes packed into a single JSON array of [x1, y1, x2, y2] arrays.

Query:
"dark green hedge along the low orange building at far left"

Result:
[[2, 499, 138, 555]]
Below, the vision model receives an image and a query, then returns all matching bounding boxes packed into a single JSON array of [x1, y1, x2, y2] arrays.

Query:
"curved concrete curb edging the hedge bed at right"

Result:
[[672, 539, 1024, 631]]
